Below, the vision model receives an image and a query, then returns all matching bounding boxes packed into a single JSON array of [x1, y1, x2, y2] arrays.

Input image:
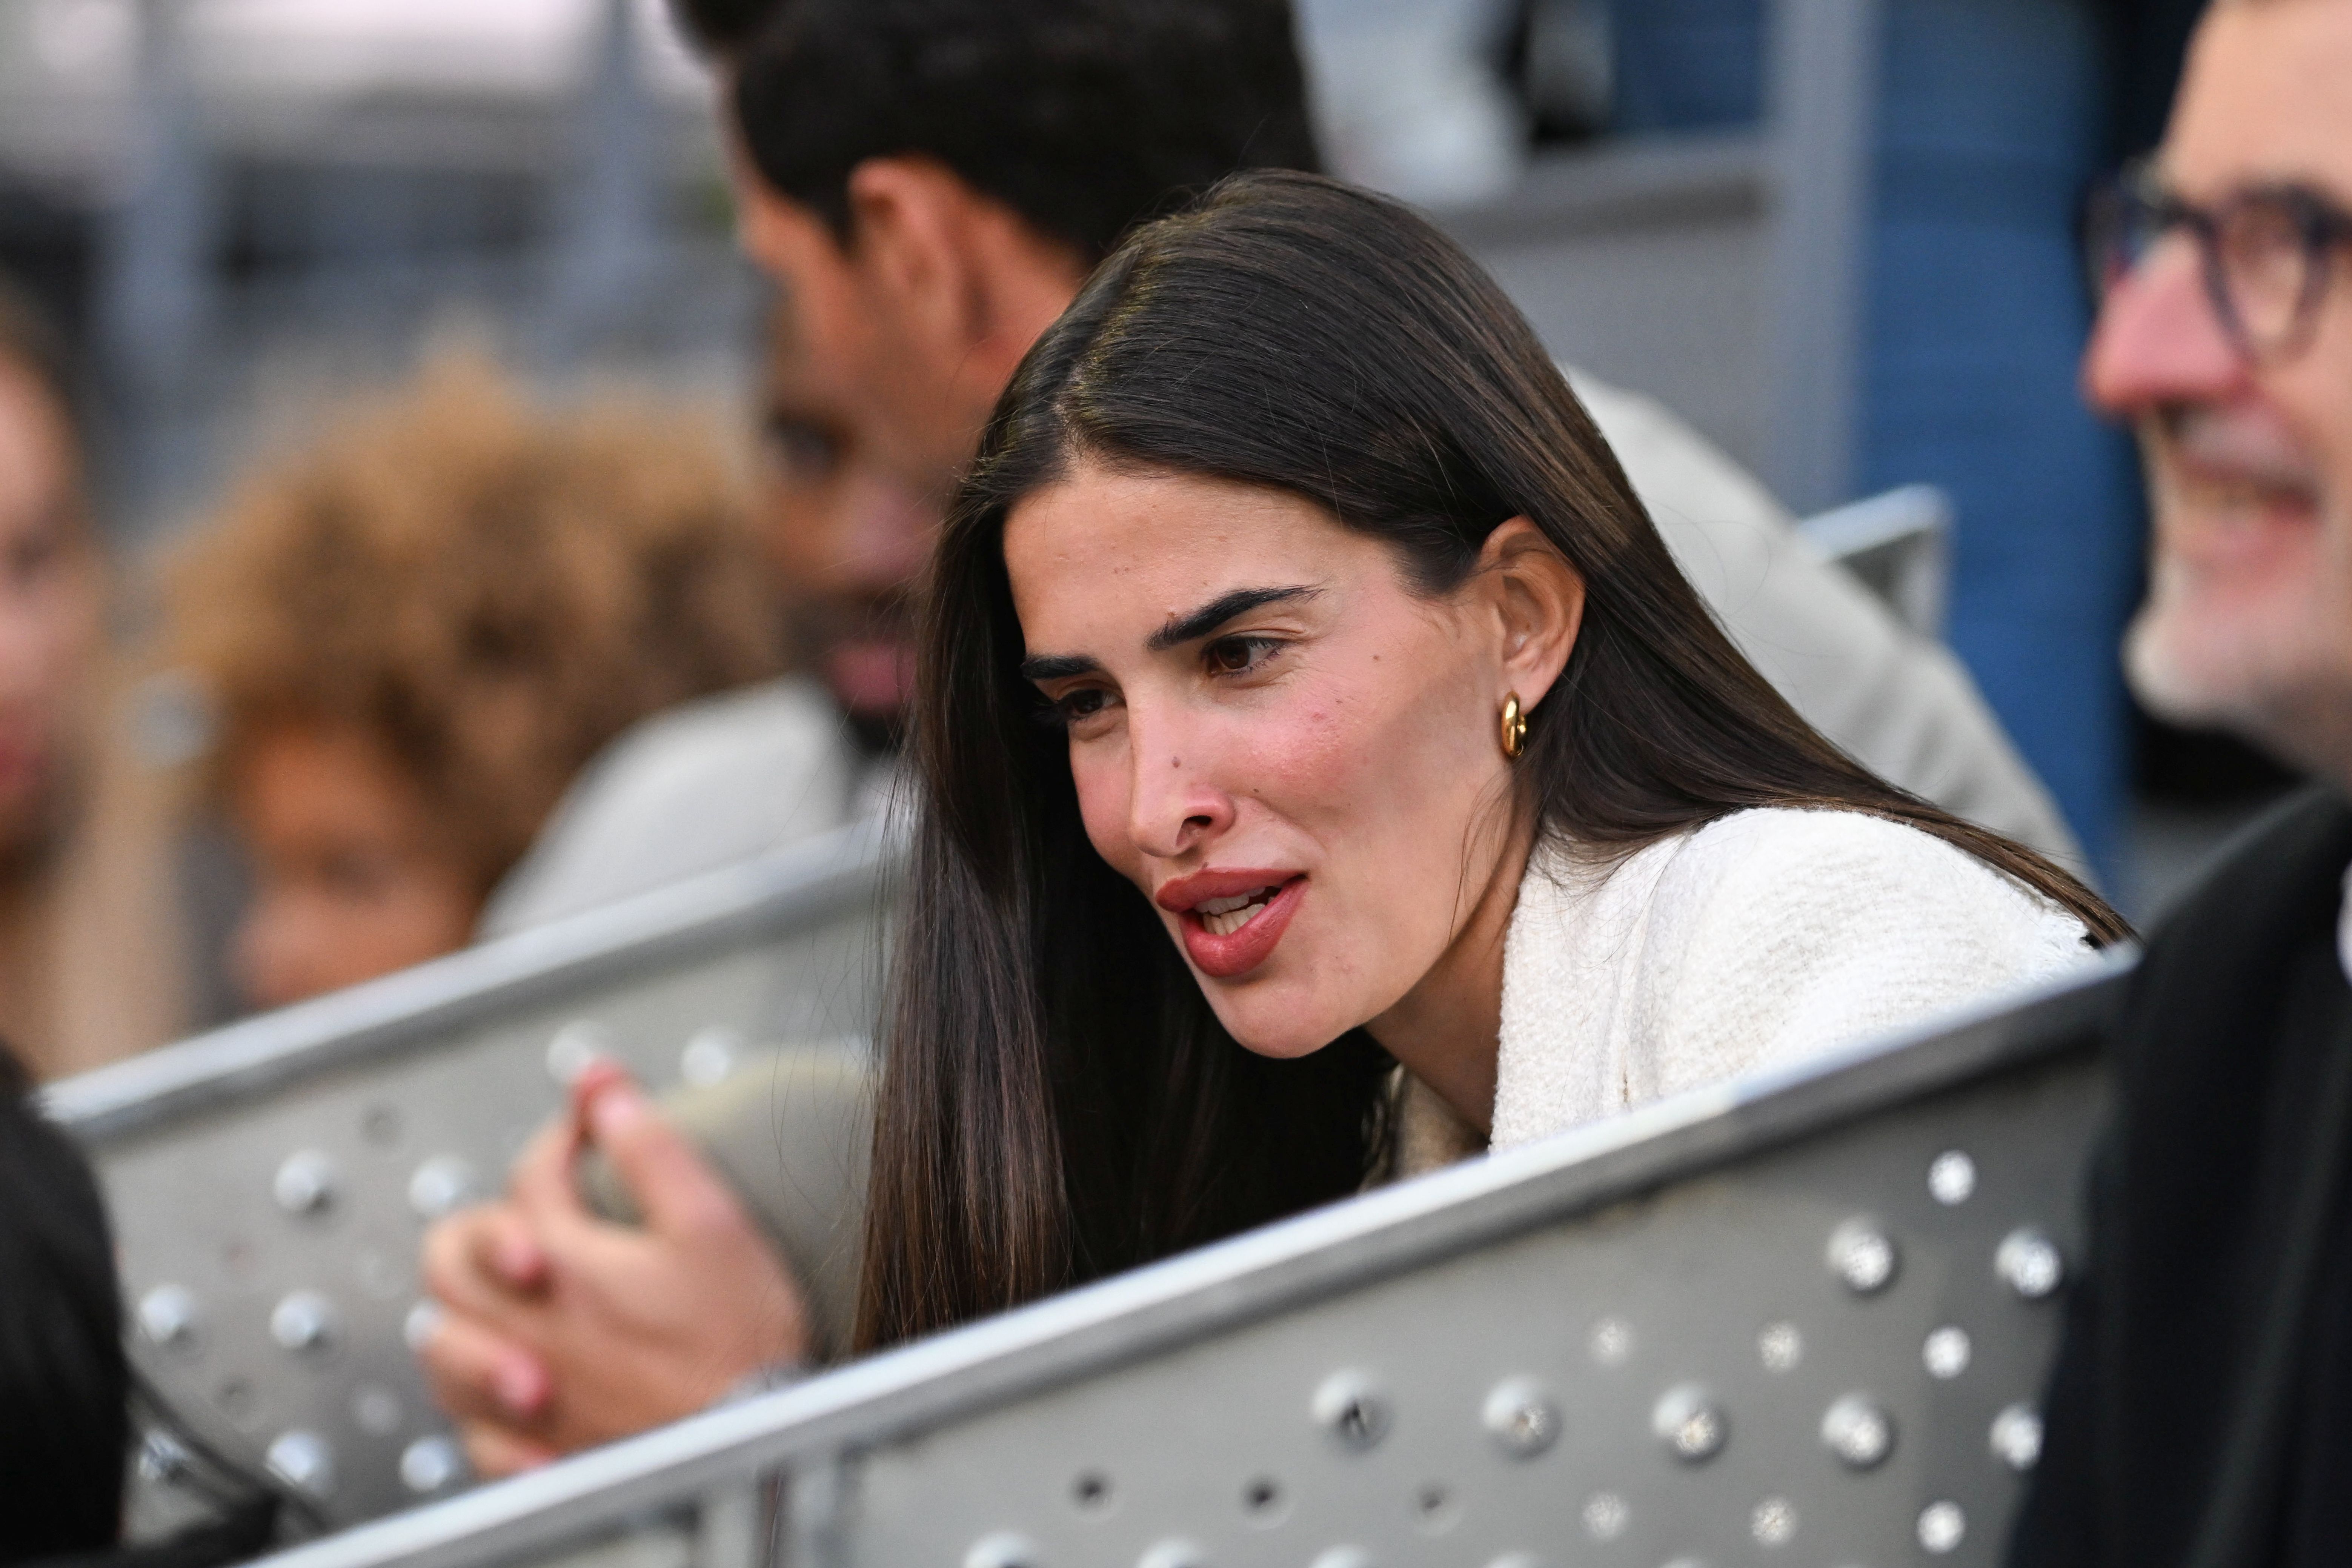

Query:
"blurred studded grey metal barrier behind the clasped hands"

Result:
[[47, 827, 887, 1523]]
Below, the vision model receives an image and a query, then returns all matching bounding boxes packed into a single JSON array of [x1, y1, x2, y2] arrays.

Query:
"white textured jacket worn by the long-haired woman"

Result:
[[1397, 809, 2091, 1173]]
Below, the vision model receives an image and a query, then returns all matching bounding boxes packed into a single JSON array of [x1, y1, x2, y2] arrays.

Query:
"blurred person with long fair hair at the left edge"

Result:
[[0, 280, 186, 1079]]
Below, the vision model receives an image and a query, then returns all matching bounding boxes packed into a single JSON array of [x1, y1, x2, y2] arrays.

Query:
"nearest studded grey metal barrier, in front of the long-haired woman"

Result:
[[238, 957, 2129, 1568]]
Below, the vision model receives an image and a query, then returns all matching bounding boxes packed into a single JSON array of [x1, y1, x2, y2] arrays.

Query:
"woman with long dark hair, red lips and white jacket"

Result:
[[861, 174, 2126, 1345]]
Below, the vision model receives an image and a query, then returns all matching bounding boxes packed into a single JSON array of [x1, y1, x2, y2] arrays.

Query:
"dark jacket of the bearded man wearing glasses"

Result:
[[2011, 792, 2352, 1568]]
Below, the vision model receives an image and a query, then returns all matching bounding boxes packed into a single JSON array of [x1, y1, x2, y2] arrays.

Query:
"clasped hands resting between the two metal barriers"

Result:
[[419, 1062, 809, 1476]]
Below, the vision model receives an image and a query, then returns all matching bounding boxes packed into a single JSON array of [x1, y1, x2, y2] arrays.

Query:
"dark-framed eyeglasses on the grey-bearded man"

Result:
[[2081, 160, 2352, 364]]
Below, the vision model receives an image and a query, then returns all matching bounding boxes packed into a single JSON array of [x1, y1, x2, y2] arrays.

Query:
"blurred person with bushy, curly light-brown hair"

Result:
[[172, 360, 804, 1006]]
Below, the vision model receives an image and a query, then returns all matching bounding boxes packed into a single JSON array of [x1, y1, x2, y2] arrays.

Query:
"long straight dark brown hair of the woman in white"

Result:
[[858, 174, 2126, 1347]]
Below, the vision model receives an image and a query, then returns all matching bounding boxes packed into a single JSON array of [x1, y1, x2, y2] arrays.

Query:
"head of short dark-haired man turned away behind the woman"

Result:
[[732, 0, 1317, 526]]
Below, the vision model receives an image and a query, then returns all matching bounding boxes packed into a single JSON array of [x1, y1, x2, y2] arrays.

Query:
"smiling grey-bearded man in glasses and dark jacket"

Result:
[[2013, 0, 2352, 1568]]
